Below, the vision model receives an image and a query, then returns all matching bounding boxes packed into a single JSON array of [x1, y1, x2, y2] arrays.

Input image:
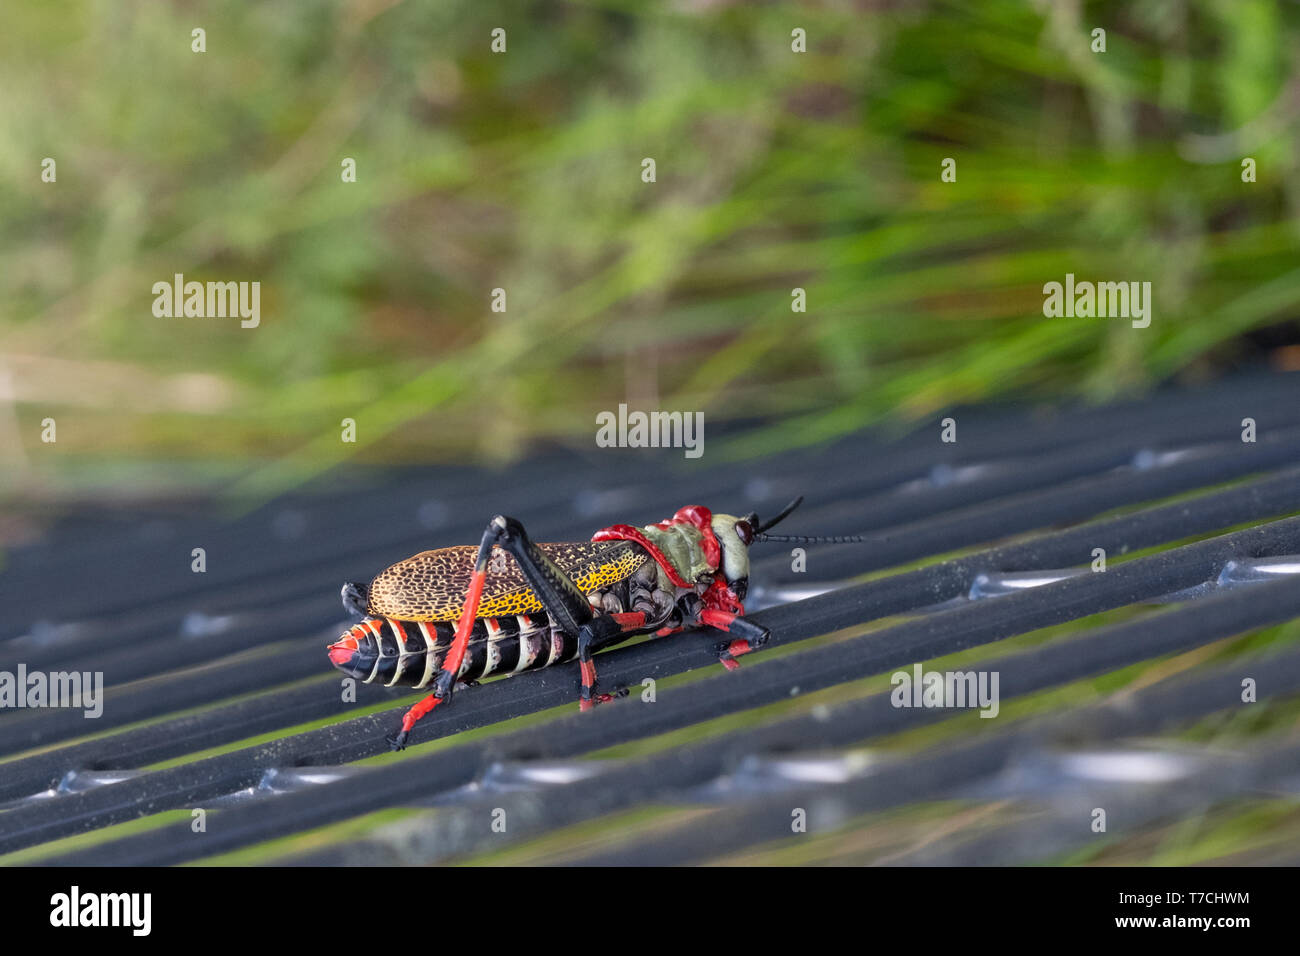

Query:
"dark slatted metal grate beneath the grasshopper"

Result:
[[0, 376, 1300, 865]]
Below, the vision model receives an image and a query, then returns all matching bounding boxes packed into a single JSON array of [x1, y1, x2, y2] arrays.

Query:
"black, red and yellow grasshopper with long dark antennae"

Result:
[[329, 498, 861, 750]]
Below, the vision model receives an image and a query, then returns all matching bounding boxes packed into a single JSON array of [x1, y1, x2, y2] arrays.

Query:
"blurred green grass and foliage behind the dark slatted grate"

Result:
[[0, 0, 1300, 504]]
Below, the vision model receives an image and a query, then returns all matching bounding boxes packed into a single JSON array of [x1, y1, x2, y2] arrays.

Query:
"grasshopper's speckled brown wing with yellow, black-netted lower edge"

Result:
[[368, 541, 650, 620]]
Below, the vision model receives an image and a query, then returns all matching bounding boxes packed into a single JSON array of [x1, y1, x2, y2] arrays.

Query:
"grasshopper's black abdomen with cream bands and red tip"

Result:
[[329, 611, 577, 688]]
